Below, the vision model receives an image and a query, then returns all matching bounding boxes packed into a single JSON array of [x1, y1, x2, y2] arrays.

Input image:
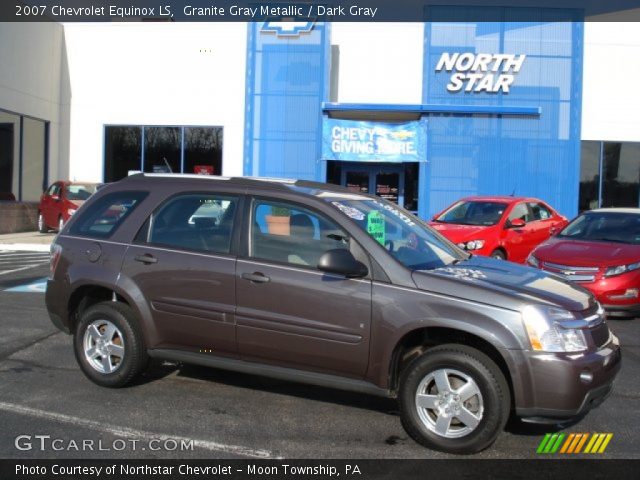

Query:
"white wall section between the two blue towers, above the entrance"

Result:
[[331, 22, 424, 104]]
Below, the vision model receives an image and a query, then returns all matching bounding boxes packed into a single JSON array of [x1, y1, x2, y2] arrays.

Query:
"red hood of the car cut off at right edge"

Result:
[[535, 237, 640, 267]]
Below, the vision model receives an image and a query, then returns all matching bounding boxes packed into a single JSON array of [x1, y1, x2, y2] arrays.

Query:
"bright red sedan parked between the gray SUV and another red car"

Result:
[[429, 196, 569, 263]]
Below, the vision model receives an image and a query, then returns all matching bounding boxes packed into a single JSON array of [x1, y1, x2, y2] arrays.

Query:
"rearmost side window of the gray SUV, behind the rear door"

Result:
[[70, 191, 147, 238]]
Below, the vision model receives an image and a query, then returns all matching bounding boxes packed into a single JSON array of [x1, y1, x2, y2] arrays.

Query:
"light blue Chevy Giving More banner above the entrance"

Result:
[[322, 118, 427, 162]]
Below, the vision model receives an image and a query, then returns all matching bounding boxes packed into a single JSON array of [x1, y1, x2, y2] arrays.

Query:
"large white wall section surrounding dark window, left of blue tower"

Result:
[[65, 23, 247, 181]]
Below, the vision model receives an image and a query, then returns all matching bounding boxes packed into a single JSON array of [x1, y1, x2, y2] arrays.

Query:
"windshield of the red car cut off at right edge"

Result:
[[558, 212, 640, 245]]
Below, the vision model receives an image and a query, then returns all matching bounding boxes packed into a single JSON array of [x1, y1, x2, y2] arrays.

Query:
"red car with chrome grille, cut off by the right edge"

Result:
[[527, 208, 640, 317]]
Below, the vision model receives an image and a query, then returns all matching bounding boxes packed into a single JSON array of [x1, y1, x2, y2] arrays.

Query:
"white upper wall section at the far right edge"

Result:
[[581, 22, 640, 142]]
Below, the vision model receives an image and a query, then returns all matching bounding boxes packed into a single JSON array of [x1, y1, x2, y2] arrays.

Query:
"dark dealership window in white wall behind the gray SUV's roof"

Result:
[[104, 125, 222, 182]]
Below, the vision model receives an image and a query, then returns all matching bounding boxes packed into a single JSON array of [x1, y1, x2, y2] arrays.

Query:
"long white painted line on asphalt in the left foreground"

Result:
[[0, 402, 276, 459]]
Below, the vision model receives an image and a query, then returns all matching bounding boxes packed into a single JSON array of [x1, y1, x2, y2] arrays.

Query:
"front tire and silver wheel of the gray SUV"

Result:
[[399, 344, 511, 454]]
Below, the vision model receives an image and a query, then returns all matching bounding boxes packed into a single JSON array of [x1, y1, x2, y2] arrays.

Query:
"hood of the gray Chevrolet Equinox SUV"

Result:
[[413, 256, 595, 312]]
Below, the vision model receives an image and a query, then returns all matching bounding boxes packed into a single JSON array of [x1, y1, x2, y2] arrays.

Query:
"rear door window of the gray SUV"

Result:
[[142, 193, 238, 254]]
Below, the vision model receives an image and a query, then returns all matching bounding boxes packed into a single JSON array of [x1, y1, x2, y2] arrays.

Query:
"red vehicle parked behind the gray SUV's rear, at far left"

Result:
[[38, 181, 97, 233]]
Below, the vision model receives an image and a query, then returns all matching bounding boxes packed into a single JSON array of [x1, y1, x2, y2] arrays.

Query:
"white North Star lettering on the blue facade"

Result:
[[436, 52, 527, 93]]
